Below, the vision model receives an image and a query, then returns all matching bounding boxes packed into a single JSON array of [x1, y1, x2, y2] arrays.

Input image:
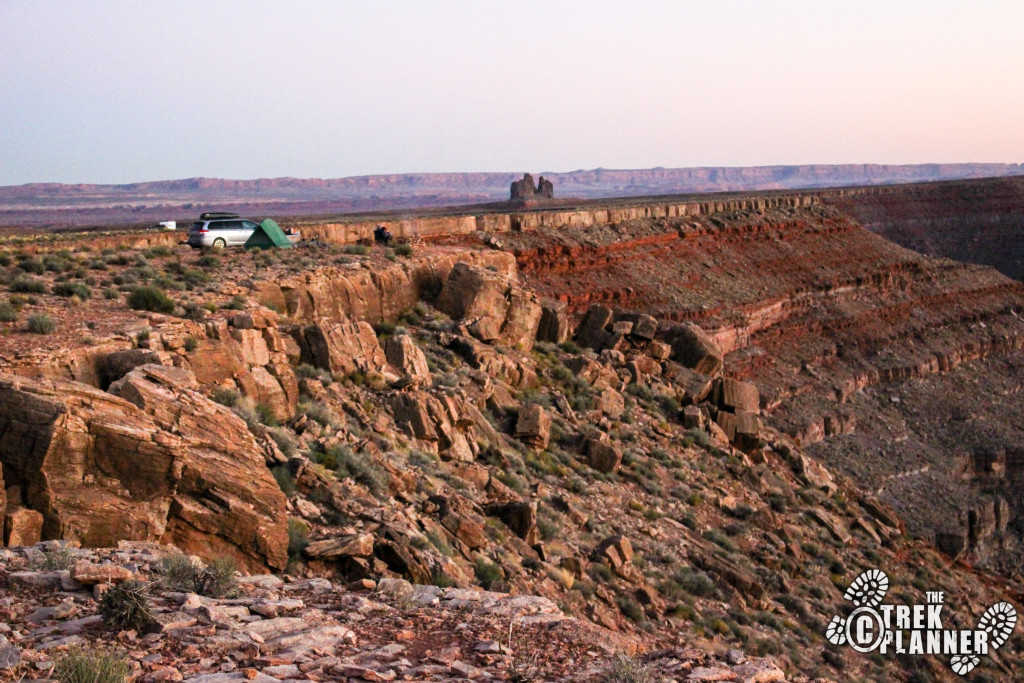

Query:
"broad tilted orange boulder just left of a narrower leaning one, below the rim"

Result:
[[302, 321, 387, 375]]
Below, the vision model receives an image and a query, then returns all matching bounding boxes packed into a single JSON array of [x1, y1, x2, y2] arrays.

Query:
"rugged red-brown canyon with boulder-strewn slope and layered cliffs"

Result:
[[0, 179, 1024, 681]]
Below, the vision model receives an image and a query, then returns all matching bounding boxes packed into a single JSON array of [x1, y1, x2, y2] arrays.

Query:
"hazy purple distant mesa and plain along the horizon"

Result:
[[0, 164, 1024, 231]]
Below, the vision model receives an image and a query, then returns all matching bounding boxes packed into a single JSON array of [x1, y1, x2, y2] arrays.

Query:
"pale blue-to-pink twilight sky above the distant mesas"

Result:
[[0, 0, 1024, 185]]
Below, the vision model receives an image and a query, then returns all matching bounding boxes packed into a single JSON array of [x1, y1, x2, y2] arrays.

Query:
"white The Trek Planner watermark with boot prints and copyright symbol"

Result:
[[825, 569, 1017, 676]]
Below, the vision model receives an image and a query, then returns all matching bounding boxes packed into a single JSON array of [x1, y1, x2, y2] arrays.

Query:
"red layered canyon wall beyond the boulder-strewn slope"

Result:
[[499, 204, 1024, 565]]
